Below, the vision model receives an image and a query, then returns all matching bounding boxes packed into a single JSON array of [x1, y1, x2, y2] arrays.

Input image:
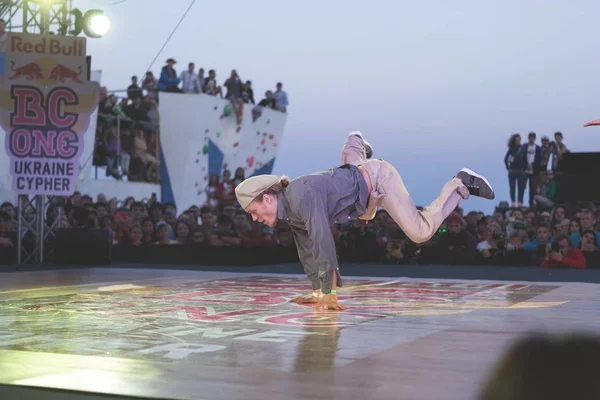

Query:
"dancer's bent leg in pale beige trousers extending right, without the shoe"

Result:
[[379, 161, 469, 243]]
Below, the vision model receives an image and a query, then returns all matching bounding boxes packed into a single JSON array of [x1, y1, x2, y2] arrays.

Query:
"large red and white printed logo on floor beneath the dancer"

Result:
[[0, 276, 566, 362]]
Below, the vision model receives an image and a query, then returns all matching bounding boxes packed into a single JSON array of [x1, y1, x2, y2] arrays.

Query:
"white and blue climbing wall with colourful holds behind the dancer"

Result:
[[159, 93, 287, 210]]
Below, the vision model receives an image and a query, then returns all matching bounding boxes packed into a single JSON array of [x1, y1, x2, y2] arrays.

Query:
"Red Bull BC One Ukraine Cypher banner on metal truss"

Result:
[[0, 33, 100, 196]]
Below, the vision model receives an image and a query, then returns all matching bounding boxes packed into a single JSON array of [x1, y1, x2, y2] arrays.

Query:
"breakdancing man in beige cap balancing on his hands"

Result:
[[235, 131, 495, 310]]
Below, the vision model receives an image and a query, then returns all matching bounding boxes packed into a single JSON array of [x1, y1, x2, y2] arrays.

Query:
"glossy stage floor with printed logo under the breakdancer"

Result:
[[0, 268, 600, 400]]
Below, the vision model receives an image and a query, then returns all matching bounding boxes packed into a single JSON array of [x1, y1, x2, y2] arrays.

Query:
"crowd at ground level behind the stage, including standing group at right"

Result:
[[0, 128, 600, 268]]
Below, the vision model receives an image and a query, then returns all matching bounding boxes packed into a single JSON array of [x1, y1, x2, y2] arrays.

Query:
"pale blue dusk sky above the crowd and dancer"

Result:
[[65, 0, 600, 213]]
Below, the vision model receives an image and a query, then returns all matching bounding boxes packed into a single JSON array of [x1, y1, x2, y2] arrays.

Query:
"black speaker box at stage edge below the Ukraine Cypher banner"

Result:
[[54, 228, 112, 265]]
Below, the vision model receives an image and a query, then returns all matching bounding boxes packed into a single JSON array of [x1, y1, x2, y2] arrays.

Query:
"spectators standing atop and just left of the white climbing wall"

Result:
[[93, 58, 288, 183]]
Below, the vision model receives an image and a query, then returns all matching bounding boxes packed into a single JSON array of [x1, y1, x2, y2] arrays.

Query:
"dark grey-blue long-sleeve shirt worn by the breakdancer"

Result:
[[277, 164, 369, 293]]
